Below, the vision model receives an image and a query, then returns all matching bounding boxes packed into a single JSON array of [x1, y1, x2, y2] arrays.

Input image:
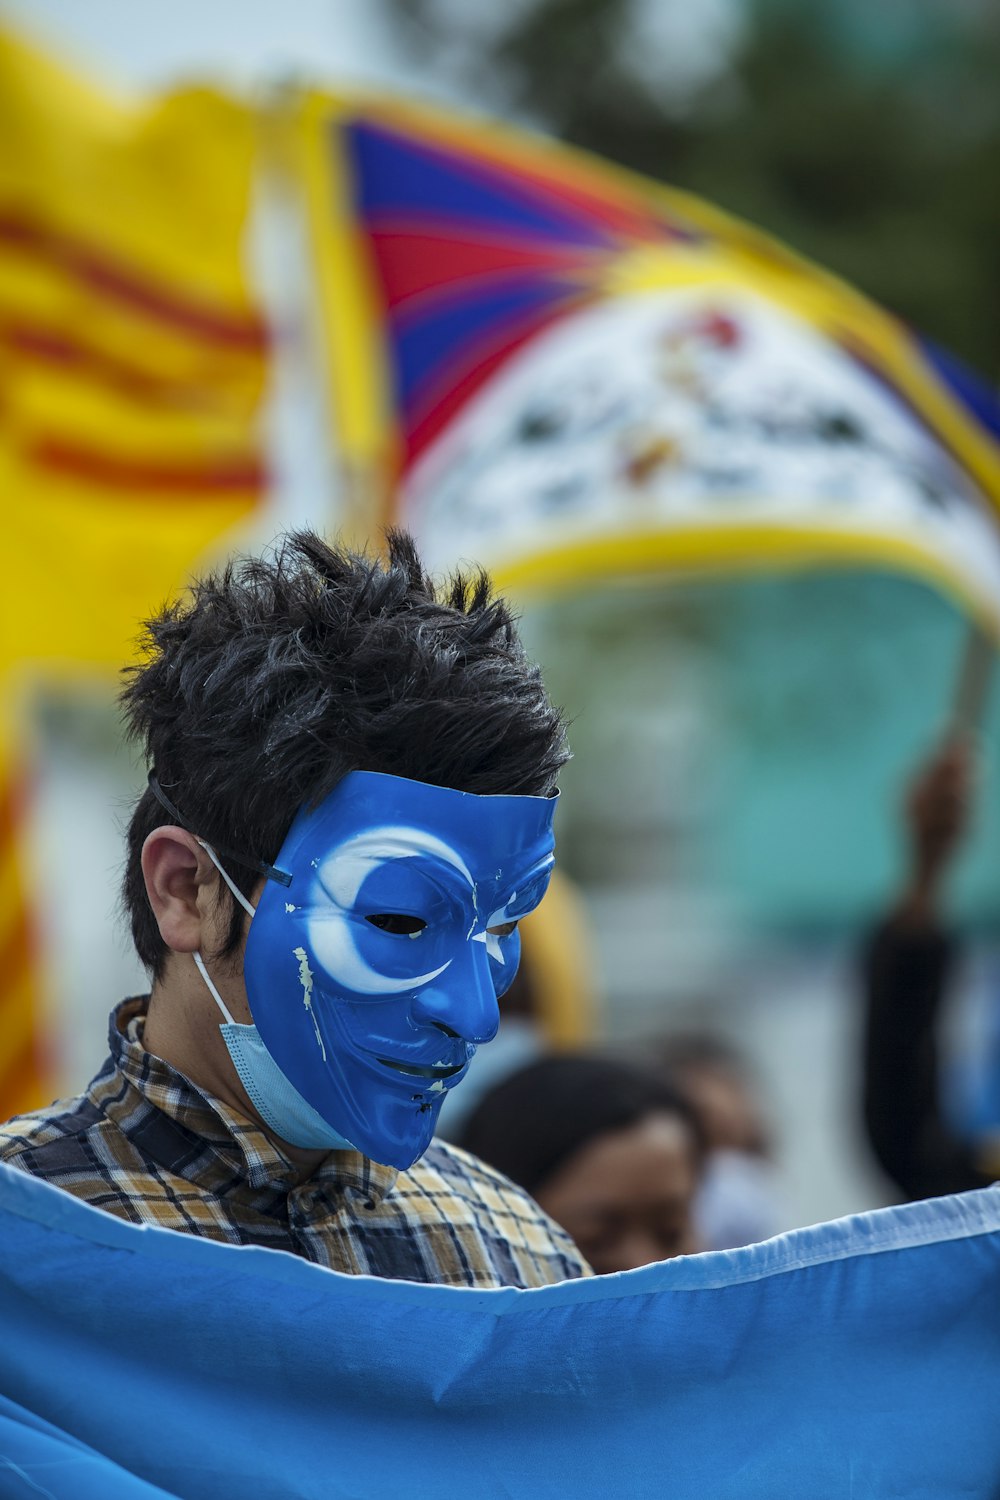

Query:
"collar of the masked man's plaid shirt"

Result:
[[108, 995, 399, 1203]]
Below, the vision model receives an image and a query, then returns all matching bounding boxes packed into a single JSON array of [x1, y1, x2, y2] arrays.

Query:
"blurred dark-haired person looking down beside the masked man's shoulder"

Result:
[[460, 1053, 703, 1275]]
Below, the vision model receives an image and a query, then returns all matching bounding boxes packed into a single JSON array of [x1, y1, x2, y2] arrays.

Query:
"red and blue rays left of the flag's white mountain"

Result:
[[328, 109, 703, 468]]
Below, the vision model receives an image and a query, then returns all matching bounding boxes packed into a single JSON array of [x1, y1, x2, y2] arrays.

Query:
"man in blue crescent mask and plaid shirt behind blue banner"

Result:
[[0, 533, 588, 1287]]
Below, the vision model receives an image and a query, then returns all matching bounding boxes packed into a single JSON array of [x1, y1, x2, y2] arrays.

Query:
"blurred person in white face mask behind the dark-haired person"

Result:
[[646, 1032, 790, 1250]]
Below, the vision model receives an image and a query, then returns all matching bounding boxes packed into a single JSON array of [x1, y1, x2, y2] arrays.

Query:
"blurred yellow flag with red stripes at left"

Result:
[[0, 33, 268, 1118]]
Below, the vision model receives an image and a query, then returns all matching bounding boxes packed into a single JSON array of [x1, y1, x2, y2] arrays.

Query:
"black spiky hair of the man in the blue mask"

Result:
[[121, 531, 568, 977]]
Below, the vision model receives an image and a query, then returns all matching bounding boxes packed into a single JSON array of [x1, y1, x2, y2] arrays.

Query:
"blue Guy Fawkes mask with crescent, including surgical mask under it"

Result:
[[233, 771, 556, 1169]]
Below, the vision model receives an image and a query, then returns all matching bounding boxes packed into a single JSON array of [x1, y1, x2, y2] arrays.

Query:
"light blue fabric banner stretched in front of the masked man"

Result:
[[0, 1167, 1000, 1500]]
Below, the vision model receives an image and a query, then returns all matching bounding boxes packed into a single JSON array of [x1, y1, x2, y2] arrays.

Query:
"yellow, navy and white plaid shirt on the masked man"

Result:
[[0, 999, 589, 1287]]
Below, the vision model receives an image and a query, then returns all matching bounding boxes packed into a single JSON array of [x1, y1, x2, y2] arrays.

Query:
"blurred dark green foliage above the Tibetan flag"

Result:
[[388, 0, 1000, 381]]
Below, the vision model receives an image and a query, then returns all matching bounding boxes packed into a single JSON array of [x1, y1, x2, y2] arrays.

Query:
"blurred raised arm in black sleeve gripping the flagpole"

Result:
[[864, 738, 1000, 1199]]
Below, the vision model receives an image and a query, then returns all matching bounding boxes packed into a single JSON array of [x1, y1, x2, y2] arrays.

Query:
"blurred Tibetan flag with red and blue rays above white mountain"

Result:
[[298, 95, 1000, 636]]
